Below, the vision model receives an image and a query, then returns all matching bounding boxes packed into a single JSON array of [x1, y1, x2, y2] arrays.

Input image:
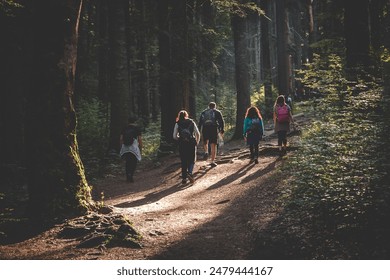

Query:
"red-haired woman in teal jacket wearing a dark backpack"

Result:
[[243, 106, 264, 164]]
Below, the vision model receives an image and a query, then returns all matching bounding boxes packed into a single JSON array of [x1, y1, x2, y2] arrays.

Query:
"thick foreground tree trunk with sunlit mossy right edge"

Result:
[[26, 0, 92, 218]]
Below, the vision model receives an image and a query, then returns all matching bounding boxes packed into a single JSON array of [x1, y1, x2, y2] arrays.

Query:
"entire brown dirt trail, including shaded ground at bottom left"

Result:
[[0, 114, 308, 259]]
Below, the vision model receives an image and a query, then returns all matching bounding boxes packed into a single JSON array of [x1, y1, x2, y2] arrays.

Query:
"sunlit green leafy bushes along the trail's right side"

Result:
[[284, 76, 390, 258]]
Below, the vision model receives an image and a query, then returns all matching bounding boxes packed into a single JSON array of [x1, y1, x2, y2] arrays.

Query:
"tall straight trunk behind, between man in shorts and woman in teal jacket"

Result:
[[232, 15, 251, 139]]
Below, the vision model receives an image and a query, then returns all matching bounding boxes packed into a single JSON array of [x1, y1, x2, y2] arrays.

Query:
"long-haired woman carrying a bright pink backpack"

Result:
[[274, 95, 294, 156]]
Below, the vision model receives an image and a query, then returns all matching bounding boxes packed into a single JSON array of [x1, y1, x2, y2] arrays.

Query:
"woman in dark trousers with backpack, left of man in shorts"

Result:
[[173, 110, 200, 184]]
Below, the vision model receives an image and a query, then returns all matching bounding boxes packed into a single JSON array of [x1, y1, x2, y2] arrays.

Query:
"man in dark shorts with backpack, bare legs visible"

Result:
[[199, 102, 225, 167]]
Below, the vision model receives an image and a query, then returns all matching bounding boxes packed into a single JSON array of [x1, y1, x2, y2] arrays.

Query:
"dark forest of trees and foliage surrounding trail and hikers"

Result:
[[0, 0, 390, 256]]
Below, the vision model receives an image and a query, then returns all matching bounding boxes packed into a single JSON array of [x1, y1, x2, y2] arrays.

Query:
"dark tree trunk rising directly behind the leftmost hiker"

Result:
[[108, 0, 132, 152]]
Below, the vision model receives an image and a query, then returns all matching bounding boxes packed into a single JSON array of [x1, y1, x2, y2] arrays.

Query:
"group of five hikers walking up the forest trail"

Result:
[[120, 95, 294, 184]]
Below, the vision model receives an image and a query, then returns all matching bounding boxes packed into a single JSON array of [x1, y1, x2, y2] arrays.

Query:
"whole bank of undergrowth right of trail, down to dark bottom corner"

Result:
[[255, 87, 390, 259]]
